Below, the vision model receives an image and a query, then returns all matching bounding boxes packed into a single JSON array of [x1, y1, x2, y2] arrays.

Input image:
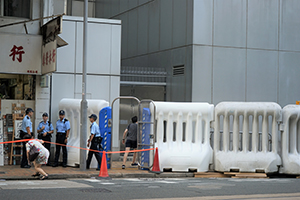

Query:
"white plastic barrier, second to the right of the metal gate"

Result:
[[214, 102, 281, 173]]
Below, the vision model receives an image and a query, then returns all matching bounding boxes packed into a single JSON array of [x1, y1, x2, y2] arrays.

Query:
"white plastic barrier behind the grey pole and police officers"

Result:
[[59, 99, 109, 168]]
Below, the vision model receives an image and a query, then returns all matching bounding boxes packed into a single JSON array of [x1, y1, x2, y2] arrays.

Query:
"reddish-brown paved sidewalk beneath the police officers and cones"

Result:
[[0, 162, 194, 180]]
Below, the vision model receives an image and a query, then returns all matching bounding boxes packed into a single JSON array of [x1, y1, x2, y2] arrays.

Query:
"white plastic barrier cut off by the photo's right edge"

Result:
[[280, 105, 300, 174]]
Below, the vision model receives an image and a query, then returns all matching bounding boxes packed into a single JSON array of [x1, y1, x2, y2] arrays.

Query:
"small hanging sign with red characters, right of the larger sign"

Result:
[[42, 40, 56, 74]]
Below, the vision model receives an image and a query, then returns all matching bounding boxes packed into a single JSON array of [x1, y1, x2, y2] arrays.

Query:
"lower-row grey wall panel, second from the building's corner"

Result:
[[213, 47, 246, 104]]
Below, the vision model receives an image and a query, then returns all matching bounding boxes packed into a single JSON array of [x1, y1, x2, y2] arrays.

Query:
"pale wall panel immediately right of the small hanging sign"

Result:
[[56, 21, 76, 73]]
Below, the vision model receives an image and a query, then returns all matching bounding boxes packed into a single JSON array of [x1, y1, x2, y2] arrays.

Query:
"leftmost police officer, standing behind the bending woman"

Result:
[[20, 108, 34, 168]]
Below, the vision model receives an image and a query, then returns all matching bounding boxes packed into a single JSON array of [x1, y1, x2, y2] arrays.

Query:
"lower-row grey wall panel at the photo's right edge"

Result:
[[279, 52, 300, 106]]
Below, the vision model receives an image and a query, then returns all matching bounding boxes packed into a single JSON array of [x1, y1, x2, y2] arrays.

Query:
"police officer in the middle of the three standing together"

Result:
[[37, 112, 54, 166]]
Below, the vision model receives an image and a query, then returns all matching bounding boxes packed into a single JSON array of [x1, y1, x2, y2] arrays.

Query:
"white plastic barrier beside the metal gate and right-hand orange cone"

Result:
[[152, 102, 214, 172]]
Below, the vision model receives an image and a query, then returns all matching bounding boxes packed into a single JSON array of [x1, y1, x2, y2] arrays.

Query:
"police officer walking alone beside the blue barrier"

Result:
[[86, 114, 102, 170]]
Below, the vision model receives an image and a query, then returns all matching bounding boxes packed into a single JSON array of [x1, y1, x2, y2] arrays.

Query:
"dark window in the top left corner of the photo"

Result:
[[0, 0, 30, 18]]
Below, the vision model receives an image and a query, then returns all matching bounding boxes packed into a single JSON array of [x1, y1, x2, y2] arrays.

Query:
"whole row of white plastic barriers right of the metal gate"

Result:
[[152, 102, 300, 174]]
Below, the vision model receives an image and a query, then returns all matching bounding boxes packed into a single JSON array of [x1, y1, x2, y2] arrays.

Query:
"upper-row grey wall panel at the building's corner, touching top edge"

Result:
[[193, 0, 213, 45]]
